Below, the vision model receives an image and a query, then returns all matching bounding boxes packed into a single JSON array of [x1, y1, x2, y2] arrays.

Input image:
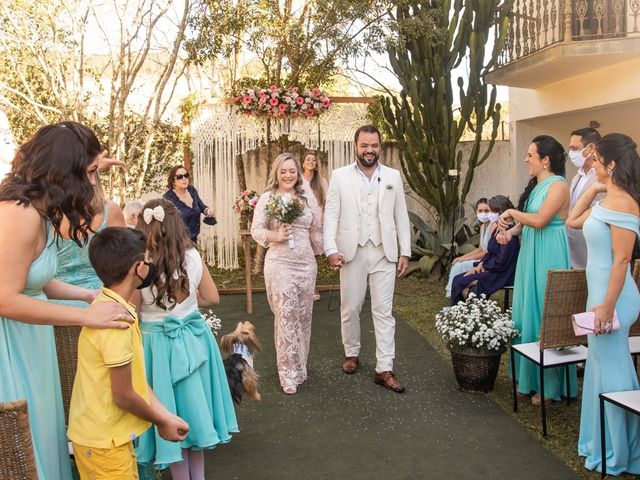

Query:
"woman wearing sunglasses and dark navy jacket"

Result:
[[163, 165, 216, 243]]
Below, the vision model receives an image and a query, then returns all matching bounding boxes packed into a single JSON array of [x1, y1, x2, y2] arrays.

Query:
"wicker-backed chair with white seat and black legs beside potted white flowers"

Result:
[[510, 270, 587, 436]]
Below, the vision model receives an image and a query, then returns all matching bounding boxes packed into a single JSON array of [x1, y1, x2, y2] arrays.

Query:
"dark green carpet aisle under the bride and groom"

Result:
[[206, 292, 578, 480]]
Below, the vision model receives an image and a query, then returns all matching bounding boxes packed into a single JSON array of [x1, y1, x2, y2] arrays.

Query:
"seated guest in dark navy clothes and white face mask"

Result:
[[451, 195, 520, 305]]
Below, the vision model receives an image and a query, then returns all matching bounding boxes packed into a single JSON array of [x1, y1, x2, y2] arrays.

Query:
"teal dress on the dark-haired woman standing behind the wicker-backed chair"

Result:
[[513, 175, 578, 400]]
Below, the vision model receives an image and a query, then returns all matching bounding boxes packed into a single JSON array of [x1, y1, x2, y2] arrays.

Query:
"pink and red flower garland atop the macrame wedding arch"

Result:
[[234, 85, 331, 117]]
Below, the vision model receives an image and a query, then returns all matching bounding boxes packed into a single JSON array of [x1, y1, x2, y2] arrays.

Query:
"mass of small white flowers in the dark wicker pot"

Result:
[[436, 293, 520, 350]]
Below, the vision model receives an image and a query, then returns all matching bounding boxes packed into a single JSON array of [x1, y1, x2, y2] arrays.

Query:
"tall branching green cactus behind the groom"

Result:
[[381, 0, 514, 278]]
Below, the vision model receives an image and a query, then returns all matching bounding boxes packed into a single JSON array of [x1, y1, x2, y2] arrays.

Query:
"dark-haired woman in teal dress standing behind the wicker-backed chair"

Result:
[[498, 135, 578, 405]]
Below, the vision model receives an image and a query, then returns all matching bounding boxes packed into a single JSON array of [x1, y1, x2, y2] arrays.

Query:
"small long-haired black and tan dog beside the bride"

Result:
[[220, 322, 262, 405]]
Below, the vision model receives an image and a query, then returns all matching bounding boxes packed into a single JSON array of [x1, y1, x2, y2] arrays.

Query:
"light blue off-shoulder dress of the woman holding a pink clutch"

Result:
[[578, 204, 640, 475]]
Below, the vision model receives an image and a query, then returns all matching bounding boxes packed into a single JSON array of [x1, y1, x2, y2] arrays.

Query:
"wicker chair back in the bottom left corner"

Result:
[[0, 400, 38, 480]]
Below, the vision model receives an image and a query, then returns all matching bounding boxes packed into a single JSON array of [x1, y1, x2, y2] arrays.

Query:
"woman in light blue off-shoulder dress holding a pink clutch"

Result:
[[567, 133, 640, 475]]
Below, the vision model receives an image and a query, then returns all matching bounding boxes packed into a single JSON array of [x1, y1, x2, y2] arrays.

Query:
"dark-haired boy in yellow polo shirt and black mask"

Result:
[[67, 227, 189, 480]]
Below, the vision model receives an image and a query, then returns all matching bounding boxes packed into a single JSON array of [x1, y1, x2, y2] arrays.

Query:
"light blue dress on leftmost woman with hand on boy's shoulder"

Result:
[[0, 222, 71, 480]]
